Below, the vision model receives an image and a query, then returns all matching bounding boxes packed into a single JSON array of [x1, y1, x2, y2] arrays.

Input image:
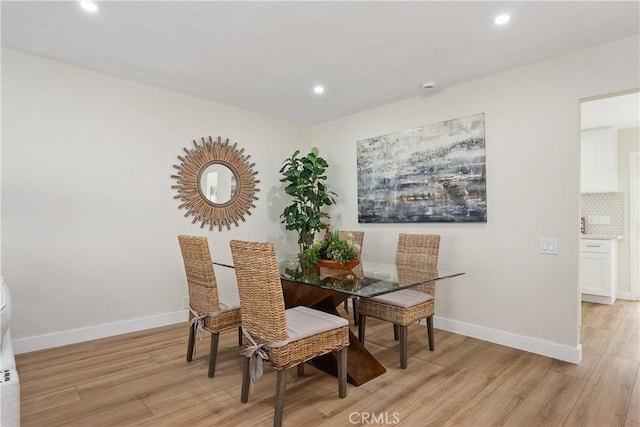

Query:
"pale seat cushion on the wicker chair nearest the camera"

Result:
[[284, 307, 349, 342]]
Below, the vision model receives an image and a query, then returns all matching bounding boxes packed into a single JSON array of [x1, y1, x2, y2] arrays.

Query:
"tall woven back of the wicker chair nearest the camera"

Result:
[[230, 240, 287, 343]]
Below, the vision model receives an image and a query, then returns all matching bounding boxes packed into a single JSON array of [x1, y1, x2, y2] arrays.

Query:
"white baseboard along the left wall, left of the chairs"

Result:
[[13, 310, 189, 354]]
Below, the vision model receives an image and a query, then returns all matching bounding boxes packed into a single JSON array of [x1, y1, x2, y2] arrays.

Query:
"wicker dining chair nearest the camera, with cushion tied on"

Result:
[[230, 240, 349, 426]]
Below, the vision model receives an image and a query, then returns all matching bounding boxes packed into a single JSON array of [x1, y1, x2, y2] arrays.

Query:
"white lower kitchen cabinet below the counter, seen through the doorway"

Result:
[[580, 238, 618, 304]]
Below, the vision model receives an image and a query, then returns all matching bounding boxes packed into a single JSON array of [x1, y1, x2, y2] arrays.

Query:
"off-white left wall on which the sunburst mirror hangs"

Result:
[[2, 49, 311, 353]]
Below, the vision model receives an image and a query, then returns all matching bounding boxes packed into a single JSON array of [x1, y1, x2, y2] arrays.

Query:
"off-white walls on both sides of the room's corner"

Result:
[[2, 37, 640, 361]]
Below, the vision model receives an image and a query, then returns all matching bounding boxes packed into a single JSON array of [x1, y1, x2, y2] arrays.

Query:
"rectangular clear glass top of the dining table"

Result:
[[278, 257, 464, 298]]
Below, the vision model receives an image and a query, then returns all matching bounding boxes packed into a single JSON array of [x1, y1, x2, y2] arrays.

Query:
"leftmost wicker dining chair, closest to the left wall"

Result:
[[178, 235, 241, 378]]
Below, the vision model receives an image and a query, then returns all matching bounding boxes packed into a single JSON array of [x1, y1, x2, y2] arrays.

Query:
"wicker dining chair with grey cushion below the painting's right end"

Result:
[[358, 233, 440, 369]]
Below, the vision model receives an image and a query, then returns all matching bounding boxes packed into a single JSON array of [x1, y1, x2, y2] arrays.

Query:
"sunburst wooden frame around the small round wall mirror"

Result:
[[171, 137, 260, 230]]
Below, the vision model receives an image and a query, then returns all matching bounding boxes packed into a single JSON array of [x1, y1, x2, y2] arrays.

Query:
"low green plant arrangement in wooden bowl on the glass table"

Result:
[[303, 230, 360, 269]]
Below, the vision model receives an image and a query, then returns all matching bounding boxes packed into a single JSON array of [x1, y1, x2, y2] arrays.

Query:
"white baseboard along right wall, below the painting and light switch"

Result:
[[433, 316, 582, 364]]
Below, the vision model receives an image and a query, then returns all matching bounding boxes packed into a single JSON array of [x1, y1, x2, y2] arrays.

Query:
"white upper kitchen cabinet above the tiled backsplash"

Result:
[[580, 127, 618, 193]]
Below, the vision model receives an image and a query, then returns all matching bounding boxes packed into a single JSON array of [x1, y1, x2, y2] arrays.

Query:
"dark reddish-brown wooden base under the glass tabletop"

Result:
[[282, 280, 386, 386]]
